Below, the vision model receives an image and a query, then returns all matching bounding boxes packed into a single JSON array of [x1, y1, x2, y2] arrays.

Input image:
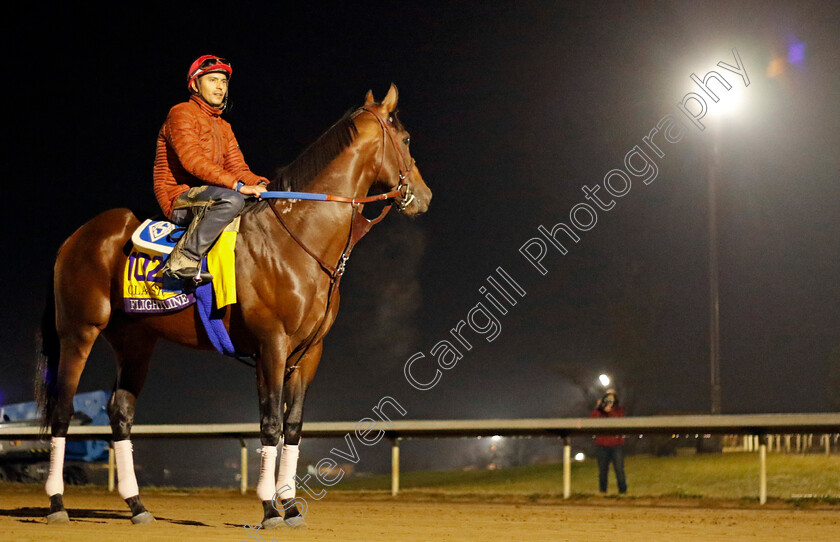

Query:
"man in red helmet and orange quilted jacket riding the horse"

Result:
[[154, 55, 268, 282]]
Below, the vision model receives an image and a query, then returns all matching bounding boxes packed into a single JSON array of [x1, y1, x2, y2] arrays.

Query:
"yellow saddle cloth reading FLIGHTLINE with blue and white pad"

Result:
[[123, 217, 239, 314]]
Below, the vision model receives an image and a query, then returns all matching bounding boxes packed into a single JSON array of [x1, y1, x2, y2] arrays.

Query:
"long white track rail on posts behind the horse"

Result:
[[0, 412, 840, 504]]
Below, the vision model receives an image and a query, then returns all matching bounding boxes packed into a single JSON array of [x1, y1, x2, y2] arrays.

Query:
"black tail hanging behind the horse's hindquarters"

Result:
[[35, 271, 61, 432]]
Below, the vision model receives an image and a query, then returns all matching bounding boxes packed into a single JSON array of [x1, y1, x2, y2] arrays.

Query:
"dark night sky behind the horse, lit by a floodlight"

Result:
[[0, 1, 840, 476]]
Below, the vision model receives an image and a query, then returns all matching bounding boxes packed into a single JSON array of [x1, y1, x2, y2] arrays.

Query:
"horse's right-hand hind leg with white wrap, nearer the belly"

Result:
[[105, 322, 156, 524]]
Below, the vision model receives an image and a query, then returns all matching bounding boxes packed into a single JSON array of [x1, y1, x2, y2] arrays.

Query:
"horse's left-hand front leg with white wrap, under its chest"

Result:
[[257, 345, 286, 529]]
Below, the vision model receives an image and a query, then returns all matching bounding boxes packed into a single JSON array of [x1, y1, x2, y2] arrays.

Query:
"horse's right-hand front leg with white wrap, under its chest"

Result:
[[274, 342, 323, 528]]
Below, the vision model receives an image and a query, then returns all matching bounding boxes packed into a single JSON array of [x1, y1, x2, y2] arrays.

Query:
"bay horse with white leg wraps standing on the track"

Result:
[[36, 85, 432, 528]]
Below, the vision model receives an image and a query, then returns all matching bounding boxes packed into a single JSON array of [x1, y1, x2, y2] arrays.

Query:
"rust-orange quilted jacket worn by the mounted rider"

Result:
[[154, 96, 268, 218]]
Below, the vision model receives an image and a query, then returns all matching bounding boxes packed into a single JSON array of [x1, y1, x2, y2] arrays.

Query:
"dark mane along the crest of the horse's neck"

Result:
[[248, 109, 359, 216]]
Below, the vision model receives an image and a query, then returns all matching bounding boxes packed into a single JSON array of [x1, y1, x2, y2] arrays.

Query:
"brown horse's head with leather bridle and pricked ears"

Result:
[[359, 84, 432, 215]]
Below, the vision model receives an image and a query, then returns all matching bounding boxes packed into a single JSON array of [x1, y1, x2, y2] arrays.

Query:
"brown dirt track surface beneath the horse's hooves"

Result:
[[0, 486, 840, 542]]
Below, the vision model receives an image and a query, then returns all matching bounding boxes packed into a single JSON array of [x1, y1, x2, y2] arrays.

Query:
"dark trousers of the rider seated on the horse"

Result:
[[172, 186, 245, 261]]
